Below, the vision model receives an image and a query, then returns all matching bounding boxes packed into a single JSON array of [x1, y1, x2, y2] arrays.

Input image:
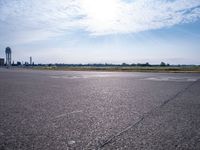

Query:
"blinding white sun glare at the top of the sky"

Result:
[[81, 0, 119, 28]]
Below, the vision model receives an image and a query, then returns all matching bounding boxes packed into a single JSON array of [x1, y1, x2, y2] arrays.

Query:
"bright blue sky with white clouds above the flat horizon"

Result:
[[0, 0, 200, 65]]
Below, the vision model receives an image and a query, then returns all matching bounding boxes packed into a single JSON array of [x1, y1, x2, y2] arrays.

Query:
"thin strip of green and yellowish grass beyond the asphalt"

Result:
[[28, 66, 200, 73]]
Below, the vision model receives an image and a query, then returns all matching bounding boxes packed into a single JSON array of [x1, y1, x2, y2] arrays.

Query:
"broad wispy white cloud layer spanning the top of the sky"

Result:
[[0, 0, 200, 42]]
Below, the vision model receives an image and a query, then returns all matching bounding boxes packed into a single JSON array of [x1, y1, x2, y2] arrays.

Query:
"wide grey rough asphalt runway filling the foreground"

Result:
[[0, 69, 200, 150]]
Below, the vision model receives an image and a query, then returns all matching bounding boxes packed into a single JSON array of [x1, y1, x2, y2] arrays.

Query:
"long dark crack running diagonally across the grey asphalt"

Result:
[[95, 79, 200, 150]]
